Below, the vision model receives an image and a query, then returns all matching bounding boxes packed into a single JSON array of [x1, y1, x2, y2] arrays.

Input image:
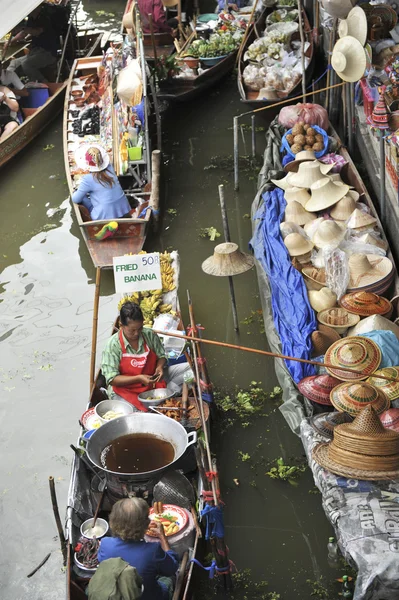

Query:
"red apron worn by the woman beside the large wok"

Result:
[[112, 329, 166, 412]]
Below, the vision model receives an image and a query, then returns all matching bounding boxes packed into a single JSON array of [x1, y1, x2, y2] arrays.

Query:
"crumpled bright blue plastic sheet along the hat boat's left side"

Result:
[[250, 188, 316, 383]]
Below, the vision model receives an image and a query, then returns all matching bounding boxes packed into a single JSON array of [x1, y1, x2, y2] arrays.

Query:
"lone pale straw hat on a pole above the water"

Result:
[[202, 242, 255, 277]]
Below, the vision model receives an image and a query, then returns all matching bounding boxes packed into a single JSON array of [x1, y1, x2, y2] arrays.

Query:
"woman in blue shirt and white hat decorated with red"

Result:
[[72, 143, 131, 221]]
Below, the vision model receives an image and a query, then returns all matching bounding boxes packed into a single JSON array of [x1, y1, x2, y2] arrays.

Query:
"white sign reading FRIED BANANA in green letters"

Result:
[[113, 252, 162, 294]]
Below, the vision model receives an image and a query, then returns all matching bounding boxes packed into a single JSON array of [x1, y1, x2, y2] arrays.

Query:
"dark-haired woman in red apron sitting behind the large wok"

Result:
[[101, 302, 166, 412]]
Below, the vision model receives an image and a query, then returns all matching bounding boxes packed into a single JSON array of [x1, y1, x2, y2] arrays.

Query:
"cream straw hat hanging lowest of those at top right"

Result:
[[331, 35, 366, 82]]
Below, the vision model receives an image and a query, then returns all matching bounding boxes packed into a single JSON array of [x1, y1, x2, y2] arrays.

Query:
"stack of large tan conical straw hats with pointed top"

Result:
[[312, 406, 399, 481]]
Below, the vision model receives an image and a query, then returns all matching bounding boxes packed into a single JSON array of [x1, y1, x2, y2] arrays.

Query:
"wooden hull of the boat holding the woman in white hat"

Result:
[[64, 42, 159, 268]]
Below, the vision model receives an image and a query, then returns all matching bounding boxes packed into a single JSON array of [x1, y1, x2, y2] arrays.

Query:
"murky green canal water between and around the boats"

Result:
[[0, 2, 339, 600]]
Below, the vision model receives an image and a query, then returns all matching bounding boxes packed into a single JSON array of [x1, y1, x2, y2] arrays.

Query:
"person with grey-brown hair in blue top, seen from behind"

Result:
[[98, 498, 179, 600]]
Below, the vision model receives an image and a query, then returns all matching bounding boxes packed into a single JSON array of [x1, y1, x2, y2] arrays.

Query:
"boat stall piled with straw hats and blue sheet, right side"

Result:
[[251, 99, 399, 600]]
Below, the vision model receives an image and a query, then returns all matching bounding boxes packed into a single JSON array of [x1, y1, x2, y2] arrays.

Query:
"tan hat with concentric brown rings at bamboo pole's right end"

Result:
[[324, 336, 381, 380]]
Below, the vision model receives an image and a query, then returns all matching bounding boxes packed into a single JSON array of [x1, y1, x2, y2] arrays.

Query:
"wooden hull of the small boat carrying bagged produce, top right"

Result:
[[237, 8, 314, 108]]
